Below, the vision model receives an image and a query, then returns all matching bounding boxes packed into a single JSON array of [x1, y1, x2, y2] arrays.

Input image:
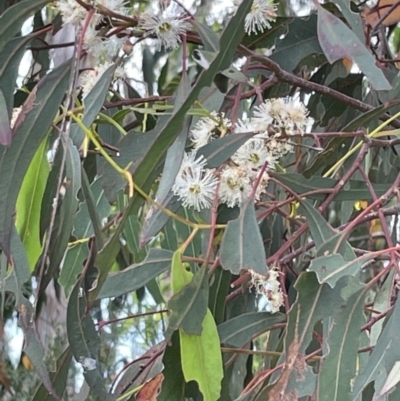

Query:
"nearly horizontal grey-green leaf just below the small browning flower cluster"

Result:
[[218, 312, 285, 347]]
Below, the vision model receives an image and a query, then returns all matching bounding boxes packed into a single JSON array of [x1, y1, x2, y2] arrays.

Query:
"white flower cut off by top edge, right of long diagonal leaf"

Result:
[[234, 0, 277, 35]]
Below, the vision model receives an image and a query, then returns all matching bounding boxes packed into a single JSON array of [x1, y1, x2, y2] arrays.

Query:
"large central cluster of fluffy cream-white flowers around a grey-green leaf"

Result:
[[172, 98, 308, 210]]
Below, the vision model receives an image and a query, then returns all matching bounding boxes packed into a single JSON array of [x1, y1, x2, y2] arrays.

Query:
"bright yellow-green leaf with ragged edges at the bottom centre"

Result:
[[179, 310, 224, 401]]
